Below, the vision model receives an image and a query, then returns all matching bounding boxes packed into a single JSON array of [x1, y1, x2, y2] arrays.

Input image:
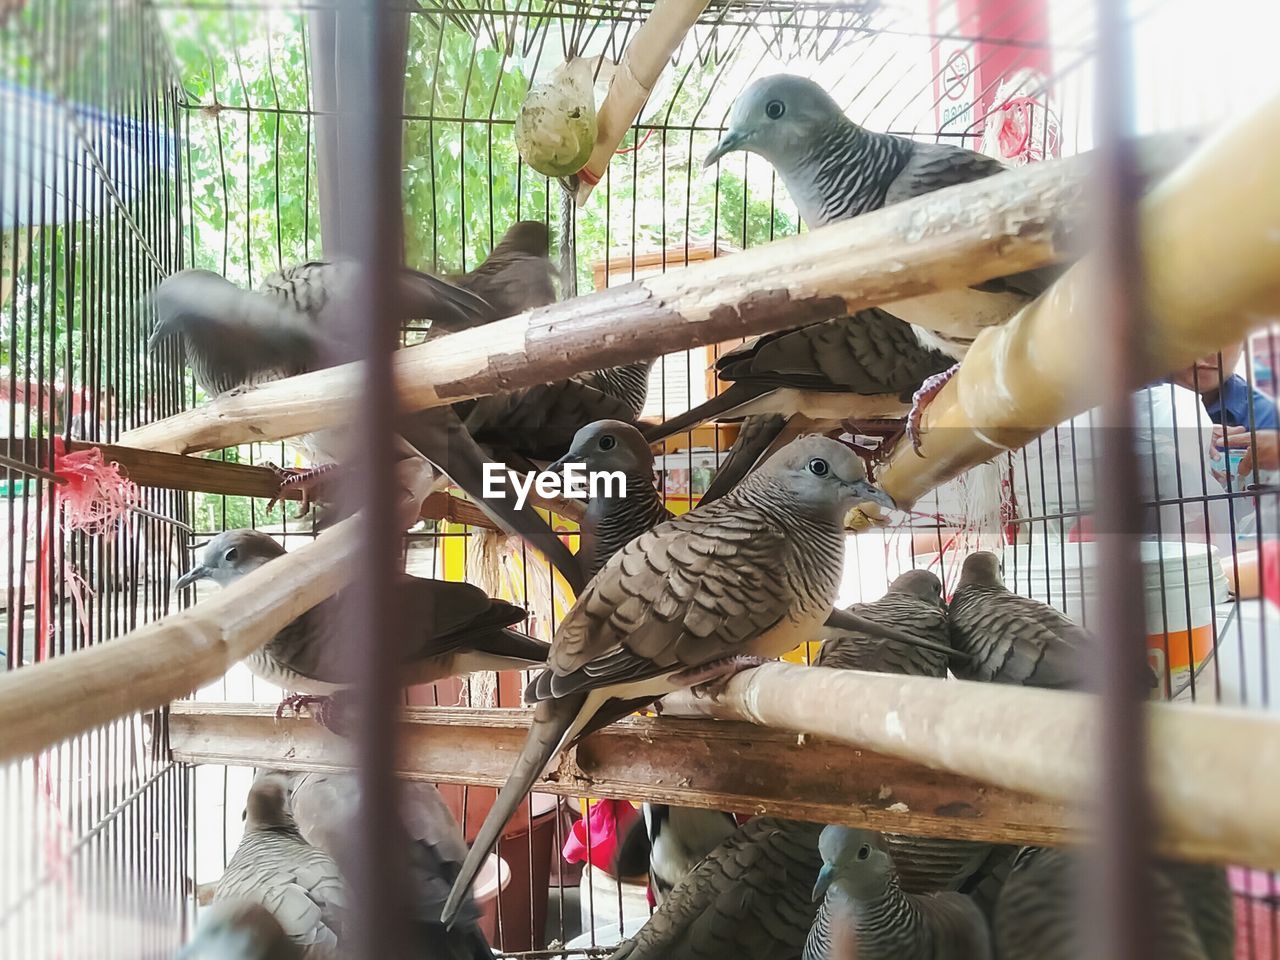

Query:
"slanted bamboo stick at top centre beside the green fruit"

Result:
[[575, 0, 708, 206]]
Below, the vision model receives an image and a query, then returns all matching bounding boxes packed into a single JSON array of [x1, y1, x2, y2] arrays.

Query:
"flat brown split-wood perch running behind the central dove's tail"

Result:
[[169, 703, 1073, 844]]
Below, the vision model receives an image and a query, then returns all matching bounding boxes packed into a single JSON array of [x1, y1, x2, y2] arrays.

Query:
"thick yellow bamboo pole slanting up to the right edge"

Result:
[[879, 97, 1280, 508]]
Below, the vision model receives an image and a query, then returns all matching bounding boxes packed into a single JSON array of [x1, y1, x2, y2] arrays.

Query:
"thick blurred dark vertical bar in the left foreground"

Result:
[[332, 0, 407, 960]]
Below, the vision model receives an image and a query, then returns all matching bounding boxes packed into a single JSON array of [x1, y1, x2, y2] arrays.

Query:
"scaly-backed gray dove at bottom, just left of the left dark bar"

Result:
[[214, 776, 348, 960]]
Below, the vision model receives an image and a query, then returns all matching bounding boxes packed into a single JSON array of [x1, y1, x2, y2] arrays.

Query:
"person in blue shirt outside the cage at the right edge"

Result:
[[1169, 344, 1280, 476]]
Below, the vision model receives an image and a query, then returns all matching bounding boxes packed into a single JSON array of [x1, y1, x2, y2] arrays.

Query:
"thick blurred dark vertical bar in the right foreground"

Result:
[[1083, 0, 1155, 960]]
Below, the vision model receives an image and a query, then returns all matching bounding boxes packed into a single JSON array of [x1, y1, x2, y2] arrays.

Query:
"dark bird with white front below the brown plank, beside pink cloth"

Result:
[[613, 804, 737, 905]]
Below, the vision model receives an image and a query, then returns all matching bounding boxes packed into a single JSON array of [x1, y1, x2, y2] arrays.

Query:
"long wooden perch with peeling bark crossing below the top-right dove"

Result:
[[122, 146, 1126, 453]]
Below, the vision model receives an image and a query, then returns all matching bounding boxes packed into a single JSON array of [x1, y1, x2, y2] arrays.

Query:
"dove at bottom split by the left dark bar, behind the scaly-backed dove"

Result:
[[289, 773, 493, 960]]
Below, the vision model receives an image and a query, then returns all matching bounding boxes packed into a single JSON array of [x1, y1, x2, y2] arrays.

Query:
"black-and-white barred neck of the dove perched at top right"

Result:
[[778, 120, 911, 227]]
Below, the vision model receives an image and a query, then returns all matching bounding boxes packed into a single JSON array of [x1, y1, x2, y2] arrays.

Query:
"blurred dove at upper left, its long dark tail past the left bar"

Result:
[[148, 260, 582, 590]]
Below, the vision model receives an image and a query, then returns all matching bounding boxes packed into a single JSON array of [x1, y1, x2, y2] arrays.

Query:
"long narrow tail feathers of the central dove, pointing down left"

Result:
[[440, 692, 589, 925]]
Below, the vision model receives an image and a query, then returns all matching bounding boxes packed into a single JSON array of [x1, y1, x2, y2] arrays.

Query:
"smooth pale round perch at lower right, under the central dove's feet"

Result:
[[666, 663, 1280, 869]]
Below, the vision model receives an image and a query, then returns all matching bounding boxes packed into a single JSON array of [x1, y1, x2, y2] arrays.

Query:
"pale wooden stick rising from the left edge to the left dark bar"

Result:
[[0, 515, 361, 763]]
